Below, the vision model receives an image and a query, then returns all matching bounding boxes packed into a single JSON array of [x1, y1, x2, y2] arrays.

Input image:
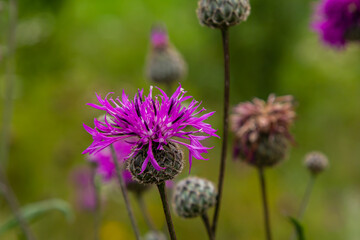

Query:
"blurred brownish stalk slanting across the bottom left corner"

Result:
[[0, 169, 35, 240]]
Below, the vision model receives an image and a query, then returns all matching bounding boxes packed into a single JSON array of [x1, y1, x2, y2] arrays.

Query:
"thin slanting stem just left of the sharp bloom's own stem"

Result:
[[111, 145, 140, 240]]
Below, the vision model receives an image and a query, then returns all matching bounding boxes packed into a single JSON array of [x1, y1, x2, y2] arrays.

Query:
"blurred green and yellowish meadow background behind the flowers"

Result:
[[0, 0, 360, 240]]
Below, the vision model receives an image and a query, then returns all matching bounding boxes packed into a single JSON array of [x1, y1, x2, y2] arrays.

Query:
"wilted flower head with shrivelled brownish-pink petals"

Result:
[[231, 95, 296, 166]]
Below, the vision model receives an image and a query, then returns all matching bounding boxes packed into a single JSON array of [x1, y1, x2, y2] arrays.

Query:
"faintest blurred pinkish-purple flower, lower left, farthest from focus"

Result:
[[71, 167, 96, 211]]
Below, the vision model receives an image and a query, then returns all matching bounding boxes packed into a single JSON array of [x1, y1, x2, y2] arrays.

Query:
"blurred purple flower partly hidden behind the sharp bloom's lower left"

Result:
[[89, 141, 131, 183]]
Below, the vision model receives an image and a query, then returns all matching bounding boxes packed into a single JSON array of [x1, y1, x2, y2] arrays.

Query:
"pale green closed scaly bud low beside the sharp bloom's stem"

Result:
[[173, 177, 217, 218]]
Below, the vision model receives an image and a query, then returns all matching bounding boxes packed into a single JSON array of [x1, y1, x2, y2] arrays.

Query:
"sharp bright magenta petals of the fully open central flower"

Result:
[[83, 85, 218, 171]]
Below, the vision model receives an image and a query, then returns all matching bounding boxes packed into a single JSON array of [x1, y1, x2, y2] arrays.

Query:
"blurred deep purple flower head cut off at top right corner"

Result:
[[313, 0, 360, 47]]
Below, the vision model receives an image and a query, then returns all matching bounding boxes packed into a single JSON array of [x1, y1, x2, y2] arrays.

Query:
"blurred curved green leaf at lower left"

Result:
[[0, 199, 74, 235]]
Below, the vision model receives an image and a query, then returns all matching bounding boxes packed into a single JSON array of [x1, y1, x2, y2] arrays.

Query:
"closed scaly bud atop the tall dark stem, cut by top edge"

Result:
[[197, 0, 250, 28]]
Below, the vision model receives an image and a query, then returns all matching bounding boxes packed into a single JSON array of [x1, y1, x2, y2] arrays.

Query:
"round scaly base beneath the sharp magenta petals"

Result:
[[128, 142, 184, 184]]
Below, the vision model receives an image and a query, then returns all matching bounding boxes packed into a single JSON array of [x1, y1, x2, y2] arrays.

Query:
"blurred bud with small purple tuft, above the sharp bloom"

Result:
[[146, 26, 187, 84]]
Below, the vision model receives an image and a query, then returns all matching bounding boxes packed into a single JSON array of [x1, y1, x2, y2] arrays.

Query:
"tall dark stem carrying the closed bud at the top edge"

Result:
[[212, 28, 230, 236]]
